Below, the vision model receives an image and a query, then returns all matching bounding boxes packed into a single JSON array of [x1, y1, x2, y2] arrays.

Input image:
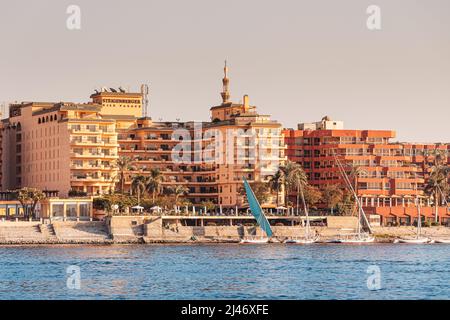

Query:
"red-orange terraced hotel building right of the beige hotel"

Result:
[[284, 117, 450, 223]]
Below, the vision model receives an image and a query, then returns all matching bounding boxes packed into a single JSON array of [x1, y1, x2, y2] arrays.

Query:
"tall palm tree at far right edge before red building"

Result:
[[425, 149, 450, 223]]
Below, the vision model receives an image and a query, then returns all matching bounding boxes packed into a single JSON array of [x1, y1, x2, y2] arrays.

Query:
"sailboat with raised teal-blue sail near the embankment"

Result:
[[240, 178, 273, 244]]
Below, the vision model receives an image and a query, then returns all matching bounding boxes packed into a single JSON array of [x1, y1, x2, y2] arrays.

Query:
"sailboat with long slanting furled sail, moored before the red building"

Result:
[[330, 152, 375, 243]]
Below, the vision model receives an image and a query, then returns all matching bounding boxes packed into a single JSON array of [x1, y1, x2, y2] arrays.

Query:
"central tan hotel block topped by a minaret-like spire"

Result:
[[118, 66, 286, 208]]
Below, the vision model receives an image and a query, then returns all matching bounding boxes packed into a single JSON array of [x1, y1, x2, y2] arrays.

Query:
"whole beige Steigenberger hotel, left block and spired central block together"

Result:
[[0, 66, 286, 207]]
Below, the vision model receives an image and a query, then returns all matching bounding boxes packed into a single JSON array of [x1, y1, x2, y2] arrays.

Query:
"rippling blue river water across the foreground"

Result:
[[0, 244, 450, 300]]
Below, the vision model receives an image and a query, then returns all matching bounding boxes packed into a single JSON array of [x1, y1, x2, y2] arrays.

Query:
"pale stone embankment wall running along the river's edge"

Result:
[[0, 216, 450, 245]]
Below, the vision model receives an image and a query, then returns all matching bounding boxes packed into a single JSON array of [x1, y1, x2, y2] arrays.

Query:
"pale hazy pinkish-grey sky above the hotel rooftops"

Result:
[[0, 0, 450, 142]]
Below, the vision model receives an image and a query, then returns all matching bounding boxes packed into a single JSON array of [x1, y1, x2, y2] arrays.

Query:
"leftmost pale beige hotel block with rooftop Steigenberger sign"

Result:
[[1, 92, 142, 196]]
